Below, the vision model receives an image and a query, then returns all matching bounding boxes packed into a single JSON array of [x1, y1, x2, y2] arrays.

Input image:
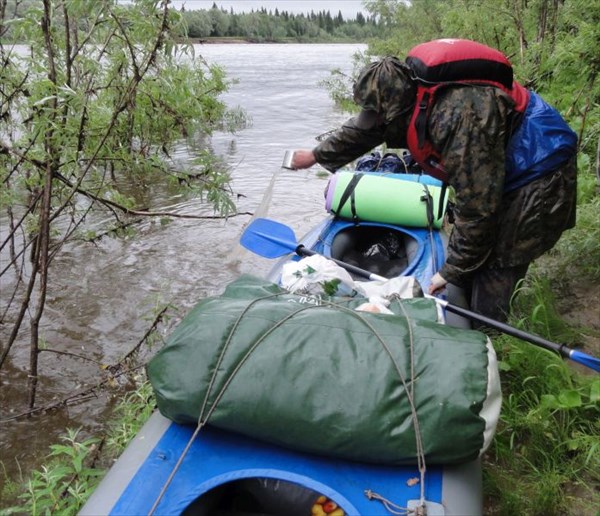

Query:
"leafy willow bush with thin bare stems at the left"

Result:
[[0, 0, 243, 408]]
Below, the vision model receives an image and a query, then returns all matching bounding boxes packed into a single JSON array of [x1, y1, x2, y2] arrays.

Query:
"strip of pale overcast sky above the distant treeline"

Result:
[[173, 0, 367, 19]]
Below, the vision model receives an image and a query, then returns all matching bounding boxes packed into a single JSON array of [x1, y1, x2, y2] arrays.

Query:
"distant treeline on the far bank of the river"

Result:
[[180, 3, 380, 42]]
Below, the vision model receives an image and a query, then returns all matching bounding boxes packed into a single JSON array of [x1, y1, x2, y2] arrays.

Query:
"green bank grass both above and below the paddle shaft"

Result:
[[484, 205, 600, 516]]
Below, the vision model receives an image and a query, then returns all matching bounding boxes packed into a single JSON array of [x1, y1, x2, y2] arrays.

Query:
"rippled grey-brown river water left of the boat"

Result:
[[0, 44, 366, 496]]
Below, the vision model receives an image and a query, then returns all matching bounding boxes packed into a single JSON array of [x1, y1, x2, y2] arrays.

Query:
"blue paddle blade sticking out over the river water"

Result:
[[240, 219, 298, 258]]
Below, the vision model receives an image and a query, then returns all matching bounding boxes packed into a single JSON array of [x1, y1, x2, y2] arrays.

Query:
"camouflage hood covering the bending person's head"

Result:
[[354, 57, 417, 123]]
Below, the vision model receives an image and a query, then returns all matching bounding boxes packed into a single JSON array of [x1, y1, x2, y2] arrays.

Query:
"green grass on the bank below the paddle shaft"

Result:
[[484, 324, 600, 515]]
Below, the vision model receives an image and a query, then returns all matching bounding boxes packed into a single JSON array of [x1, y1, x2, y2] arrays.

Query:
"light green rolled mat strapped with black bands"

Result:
[[325, 171, 447, 229]]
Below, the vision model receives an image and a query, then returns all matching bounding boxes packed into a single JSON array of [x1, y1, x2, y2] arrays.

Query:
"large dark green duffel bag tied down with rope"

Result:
[[148, 276, 501, 465]]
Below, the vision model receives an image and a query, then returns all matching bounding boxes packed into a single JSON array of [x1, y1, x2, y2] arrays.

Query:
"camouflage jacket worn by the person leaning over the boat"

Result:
[[314, 86, 576, 285]]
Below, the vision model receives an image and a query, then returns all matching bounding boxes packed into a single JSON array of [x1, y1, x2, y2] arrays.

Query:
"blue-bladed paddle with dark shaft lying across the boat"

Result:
[[240, 218, 600, 371]]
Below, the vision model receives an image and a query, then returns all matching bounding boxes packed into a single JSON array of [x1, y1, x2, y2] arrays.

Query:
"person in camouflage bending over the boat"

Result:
[[292, 39, 577, 321]]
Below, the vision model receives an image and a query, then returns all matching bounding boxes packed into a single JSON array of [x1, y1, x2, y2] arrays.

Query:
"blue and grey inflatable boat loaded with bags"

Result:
[[80, 166, 492, 516]]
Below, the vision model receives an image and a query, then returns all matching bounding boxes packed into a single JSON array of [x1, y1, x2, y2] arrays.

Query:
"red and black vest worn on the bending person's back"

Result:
[[406, 39, 529, 182]]
